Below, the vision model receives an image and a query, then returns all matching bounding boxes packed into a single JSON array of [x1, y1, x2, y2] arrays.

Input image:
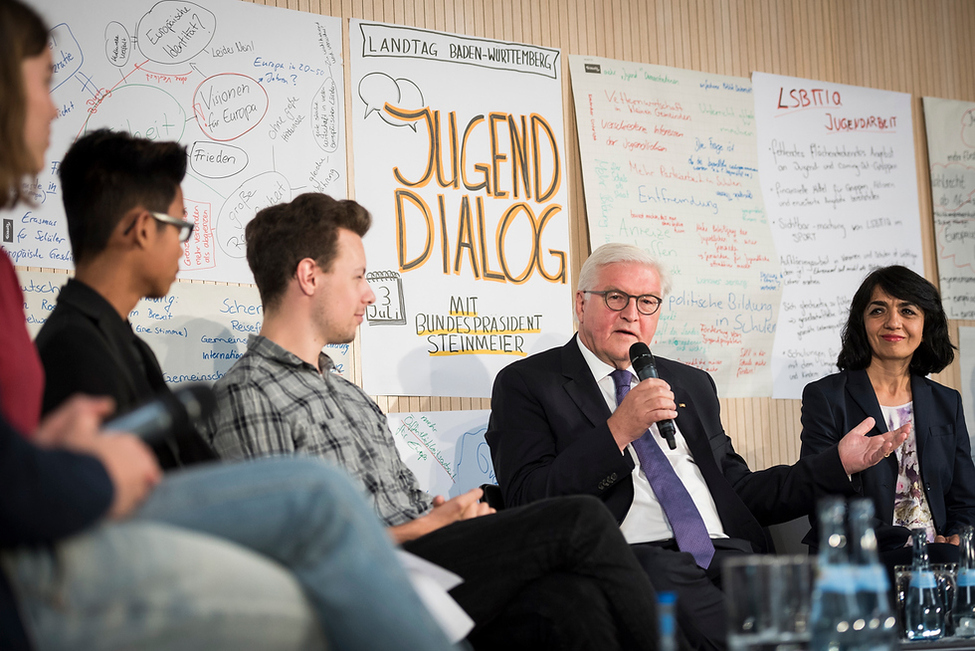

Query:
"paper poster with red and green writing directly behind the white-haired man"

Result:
[[569, 56, 780, 398]]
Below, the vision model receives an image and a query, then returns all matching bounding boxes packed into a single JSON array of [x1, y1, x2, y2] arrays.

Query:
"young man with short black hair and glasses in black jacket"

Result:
[[36, 129, 214, 468]]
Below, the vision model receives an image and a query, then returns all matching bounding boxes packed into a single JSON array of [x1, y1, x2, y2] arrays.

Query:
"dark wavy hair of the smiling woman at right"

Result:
[[836, 265, 955, 375]]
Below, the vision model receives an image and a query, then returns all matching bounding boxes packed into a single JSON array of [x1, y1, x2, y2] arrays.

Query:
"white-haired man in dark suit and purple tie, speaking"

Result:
[[485, 244, 906, 649]]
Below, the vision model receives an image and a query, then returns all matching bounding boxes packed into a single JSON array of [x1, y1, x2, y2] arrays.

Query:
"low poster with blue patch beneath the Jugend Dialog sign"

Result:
[[386, 409, 498, 498]]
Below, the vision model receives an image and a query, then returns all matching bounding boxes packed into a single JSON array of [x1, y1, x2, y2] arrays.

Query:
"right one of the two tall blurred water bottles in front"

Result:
[[849, 498, 897, 651]]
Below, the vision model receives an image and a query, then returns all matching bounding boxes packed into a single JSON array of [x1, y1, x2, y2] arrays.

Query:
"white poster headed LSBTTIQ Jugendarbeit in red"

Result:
[[752, 72, 924, 398]]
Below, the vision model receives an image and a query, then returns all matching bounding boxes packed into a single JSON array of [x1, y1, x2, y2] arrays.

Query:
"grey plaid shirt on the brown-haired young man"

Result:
[[208, 336, 431, 526]]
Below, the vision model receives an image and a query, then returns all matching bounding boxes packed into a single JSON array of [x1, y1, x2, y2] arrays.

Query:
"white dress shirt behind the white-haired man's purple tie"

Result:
[[576, 338, 728, 544]]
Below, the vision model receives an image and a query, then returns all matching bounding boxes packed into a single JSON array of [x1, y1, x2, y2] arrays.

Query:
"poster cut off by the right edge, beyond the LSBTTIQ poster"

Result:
[[924, 97, 975, 320]]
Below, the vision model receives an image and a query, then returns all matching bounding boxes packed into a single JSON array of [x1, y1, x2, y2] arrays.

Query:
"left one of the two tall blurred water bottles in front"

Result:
[[809, 497, 863, 651]]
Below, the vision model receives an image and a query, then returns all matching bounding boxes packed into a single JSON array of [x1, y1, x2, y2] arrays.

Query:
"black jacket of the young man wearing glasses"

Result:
[[35, 279, 216, 468]]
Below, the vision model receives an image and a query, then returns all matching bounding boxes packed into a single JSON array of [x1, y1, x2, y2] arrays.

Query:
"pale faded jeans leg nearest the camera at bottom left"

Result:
[[4, 522, 324, 651]]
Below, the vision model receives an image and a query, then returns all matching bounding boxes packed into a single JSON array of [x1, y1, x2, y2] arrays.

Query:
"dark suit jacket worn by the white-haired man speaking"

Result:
[[485, 337, 850, 551]]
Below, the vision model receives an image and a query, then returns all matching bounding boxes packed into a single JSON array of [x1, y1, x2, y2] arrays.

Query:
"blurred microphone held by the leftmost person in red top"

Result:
[[103, 384, 217, 445]]
